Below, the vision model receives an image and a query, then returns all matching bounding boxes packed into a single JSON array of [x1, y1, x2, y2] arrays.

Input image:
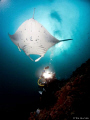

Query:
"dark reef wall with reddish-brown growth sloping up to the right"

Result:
[[28, 59, 90, 120]]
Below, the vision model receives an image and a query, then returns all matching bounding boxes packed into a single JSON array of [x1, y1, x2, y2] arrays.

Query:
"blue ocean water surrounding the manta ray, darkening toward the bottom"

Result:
[[0, 0, 90, 119]]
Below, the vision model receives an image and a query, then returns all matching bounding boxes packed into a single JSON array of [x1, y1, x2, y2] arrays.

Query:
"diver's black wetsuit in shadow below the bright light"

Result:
[[40, 79, 60, 108]]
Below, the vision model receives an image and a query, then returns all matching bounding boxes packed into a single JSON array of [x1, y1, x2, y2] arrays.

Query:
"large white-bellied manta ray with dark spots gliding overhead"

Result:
[[8, 9, 72, 62]]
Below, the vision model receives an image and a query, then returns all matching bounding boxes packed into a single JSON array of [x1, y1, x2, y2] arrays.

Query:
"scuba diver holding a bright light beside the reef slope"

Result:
[[37, 66, 60, 109]]
